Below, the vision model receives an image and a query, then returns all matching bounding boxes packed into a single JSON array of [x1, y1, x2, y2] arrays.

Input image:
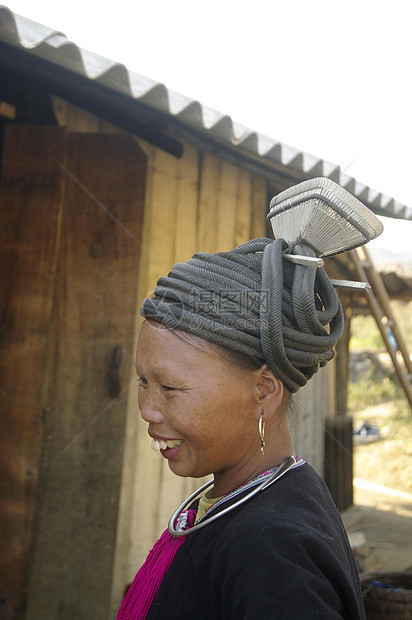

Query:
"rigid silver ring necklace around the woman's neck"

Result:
[[168, 456, 296, 537]]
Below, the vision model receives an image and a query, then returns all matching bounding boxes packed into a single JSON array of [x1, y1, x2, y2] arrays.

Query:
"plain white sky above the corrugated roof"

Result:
[[7, 0, 412, 252]]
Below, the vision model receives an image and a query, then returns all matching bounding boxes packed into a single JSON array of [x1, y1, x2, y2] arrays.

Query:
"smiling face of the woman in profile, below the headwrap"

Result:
[[136, 321, 259, 490]]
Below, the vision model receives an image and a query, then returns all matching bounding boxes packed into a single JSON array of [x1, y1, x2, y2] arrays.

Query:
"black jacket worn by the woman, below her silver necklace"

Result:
[[147, 464, 365, 620]]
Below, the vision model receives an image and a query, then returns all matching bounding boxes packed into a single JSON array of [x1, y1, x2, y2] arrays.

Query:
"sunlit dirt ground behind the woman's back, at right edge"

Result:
[[342, 401, 412, 572]]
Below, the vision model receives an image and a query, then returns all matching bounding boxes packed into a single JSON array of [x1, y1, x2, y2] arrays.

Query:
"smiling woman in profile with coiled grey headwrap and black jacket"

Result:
[[118, 180, 374, 620]]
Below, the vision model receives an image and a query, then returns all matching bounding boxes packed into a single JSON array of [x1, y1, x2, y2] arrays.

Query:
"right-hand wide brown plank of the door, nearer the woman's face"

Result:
[[27, 134, 145, 620]]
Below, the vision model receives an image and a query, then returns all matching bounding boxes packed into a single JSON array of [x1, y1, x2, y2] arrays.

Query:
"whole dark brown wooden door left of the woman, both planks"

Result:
[[0, 126, 146, 620]]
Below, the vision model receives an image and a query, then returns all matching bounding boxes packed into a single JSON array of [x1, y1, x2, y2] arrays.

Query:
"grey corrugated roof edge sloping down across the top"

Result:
[[0, 7, 412, 219]]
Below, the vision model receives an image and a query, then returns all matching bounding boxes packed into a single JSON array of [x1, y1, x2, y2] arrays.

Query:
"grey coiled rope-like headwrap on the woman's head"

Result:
[[141, 238, 343, 392]]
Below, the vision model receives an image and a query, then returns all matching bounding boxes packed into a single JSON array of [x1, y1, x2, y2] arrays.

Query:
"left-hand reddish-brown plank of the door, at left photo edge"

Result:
[[0, 125, 64, 613]]
